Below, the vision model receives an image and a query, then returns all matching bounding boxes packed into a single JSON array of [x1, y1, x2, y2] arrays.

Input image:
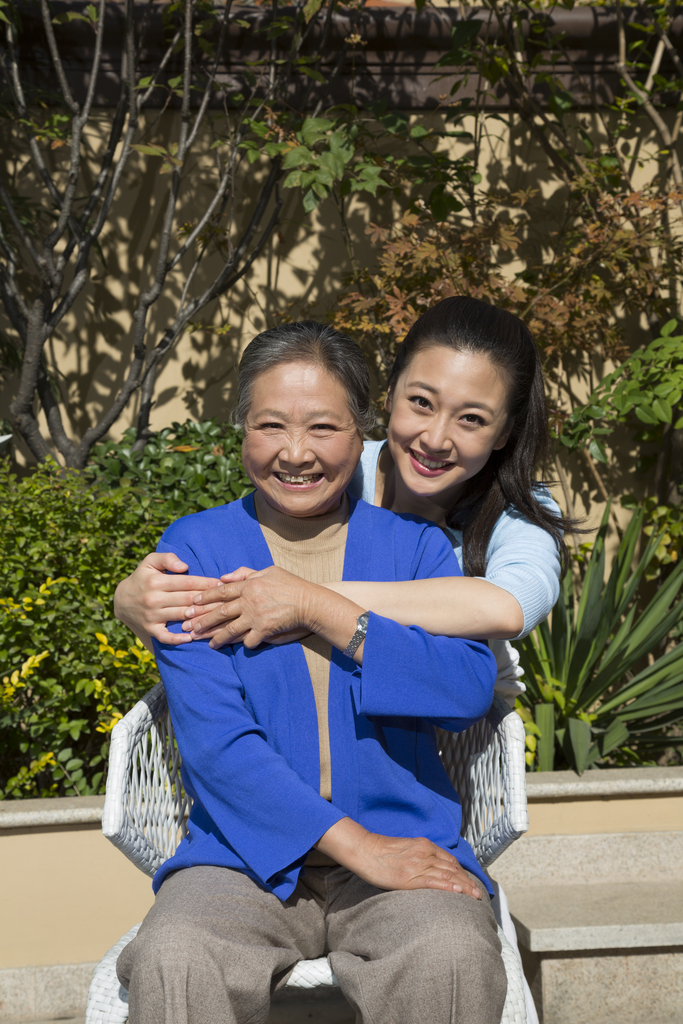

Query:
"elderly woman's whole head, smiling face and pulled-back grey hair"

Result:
[[238, 322, 371, 518]]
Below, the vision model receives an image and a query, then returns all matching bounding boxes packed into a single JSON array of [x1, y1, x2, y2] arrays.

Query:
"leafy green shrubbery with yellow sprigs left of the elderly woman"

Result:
[[0, 421, 251, 799]]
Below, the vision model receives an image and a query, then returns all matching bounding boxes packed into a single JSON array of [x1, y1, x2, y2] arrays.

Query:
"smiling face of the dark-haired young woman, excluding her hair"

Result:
[[386, 345, 512, 524]]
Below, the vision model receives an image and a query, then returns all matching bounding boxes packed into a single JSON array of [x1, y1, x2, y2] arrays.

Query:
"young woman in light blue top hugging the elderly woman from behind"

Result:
[[116, 296, 566, 1021]]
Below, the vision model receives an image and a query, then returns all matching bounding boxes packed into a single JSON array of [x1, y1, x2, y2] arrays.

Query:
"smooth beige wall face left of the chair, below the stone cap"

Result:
[[0, 824, 154, 969]]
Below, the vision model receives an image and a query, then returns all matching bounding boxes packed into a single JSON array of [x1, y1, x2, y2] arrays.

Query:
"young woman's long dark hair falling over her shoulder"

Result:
[[388, 295, 577, 577]]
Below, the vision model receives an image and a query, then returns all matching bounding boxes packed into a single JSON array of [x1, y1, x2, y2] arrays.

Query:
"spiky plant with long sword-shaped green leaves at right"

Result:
[[516, 509, 683, 774]]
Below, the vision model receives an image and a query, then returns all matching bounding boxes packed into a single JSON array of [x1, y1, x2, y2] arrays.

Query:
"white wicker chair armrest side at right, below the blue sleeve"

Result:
[[436, 695, 528, 867]]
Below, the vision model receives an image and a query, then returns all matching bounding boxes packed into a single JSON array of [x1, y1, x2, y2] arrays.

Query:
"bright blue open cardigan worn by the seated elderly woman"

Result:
[[154, 495, 496, 900]]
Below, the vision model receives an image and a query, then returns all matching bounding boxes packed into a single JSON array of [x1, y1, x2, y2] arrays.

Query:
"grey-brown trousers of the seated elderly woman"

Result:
[[117, 866, 507, 1024]]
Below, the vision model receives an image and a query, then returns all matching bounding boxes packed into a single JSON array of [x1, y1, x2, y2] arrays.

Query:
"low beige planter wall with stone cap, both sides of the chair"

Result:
[[0, 768, 683, 970]]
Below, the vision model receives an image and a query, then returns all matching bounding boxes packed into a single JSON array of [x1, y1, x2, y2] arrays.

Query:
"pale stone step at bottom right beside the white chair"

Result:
[[499, 872, 683, 1024]]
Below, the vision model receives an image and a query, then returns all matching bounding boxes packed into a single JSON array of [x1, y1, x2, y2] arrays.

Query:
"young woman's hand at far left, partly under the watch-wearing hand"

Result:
[[114, 553, 219, 644]]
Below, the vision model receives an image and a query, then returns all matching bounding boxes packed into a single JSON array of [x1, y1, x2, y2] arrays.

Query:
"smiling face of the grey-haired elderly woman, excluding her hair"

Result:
[[242, 361, 362, 517]]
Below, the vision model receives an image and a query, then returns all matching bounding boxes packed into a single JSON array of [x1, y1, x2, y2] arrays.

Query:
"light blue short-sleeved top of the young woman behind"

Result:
[[347, 440, 560, 639]]
